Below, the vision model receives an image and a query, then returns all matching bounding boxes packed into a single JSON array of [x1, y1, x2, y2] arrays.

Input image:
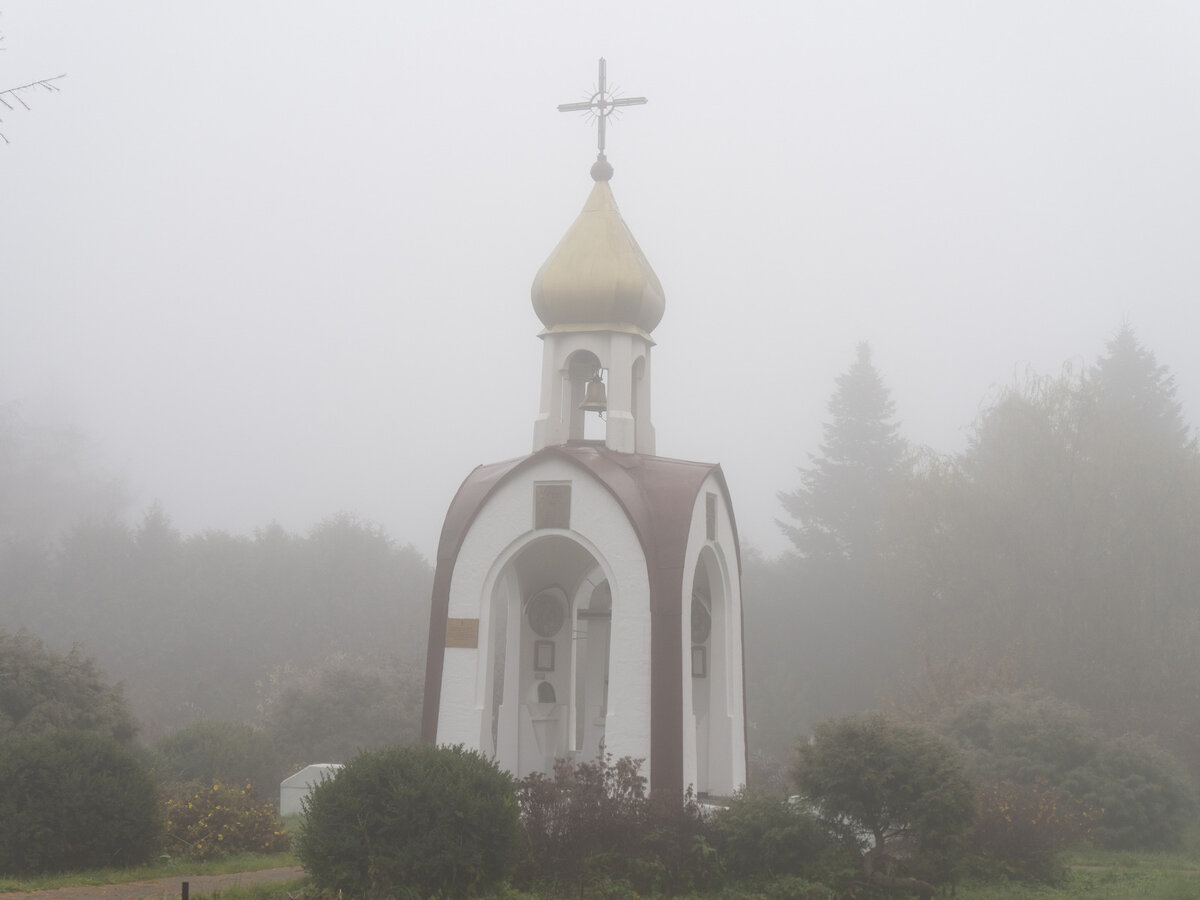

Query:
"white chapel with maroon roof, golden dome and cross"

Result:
[[421, 60, 746, 797]]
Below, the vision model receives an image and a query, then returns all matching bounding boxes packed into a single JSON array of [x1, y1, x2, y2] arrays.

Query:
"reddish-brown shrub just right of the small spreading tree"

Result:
[[971, 781, 1098, 882]]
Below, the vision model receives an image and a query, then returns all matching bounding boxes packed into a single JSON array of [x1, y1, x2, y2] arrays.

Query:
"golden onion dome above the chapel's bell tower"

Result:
[[532, 155, 666, 334]]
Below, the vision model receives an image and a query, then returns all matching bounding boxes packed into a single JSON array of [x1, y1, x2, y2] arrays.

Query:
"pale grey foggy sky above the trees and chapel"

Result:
[[0, 0, 1200, 556]]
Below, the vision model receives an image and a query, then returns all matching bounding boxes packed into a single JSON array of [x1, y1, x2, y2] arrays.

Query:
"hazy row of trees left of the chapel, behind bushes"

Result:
[[0, 513, 432, 740]]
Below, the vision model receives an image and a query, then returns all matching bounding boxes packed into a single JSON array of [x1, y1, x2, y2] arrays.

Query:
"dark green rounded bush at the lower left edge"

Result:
[[0, 731, 162, 875]]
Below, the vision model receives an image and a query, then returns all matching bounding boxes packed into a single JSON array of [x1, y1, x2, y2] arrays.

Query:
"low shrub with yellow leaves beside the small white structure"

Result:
[[167, 781, 290, 859]]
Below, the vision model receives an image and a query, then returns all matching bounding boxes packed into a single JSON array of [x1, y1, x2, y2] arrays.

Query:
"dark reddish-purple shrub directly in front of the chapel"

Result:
[[517, 756, 716, 894]]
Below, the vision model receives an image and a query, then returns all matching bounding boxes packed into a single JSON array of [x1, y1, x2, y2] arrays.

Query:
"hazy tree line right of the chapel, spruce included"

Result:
[[743, 325, 1200, 778]]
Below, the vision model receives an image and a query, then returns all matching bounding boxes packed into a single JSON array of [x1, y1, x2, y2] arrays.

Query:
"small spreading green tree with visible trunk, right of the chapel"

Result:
[[792, 714, 974, 898]]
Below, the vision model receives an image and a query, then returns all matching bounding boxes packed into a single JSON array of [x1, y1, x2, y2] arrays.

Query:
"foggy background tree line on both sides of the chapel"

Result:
[[0, 326, 1200, 786]]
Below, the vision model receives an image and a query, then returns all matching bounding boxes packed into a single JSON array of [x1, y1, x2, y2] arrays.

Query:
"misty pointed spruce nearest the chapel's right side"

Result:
[[768, 343, 908, 739]]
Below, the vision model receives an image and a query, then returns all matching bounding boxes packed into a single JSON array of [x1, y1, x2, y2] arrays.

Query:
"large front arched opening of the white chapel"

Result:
[[484, 534, 612, 778]]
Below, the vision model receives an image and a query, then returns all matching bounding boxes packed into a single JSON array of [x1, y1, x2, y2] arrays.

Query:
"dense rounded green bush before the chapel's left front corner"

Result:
[[296, 745, 520, 898]]
